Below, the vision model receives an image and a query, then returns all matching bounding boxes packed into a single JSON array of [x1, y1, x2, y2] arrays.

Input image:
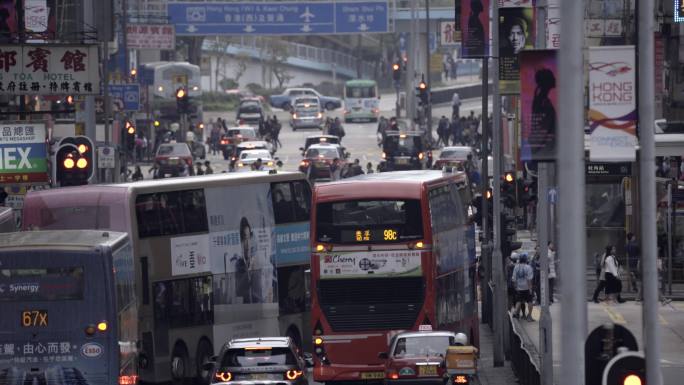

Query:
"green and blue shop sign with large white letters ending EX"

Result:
[[0, 123, 48, 185]]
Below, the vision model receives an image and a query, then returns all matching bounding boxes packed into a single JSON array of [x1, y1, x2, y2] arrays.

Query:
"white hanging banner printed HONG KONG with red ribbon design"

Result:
[[589, 46, 637, 162]]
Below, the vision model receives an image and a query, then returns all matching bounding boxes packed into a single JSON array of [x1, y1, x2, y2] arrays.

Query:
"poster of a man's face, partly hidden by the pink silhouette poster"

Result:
[[499, 7, 535, 94]]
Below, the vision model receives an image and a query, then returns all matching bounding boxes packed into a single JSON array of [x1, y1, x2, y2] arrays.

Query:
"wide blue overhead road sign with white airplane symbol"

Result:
[[167, 0, 389, 36]]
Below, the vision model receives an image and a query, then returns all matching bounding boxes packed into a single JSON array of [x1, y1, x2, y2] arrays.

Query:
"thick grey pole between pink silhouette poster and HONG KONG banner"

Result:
[[560, 0, 584, 385]]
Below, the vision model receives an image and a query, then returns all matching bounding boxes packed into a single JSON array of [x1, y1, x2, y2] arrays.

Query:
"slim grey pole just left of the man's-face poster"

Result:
[[491, 1, 506, 366]]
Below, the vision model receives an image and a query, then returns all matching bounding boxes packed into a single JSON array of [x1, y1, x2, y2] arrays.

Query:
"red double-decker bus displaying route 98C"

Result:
[[311, 171, 479, 383]]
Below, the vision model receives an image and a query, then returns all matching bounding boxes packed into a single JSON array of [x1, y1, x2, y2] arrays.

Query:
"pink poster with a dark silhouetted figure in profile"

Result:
[[520, 49, 558, 162]]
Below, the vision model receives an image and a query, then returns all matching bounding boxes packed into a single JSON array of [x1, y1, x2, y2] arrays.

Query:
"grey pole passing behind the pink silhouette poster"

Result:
[[535, 0, 554, 385]]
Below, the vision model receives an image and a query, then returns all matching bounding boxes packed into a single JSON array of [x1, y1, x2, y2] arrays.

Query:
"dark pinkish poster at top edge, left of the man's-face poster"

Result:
[[461, 0, 489, 58]]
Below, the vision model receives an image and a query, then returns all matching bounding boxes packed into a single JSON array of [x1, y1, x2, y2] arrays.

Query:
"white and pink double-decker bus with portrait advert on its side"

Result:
[[23, 172, 311, 383]]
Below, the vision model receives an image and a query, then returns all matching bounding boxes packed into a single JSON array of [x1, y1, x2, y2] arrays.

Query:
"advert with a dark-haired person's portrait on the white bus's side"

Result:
[[205, 184, 277, 304]]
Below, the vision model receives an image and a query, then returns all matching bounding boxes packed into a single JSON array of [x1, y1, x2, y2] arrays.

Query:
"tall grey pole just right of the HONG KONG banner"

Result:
[[636, 0, 663, 385]]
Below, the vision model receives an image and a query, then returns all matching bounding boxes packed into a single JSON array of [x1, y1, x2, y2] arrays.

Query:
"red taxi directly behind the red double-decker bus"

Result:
[[378, 325, 457, 385]]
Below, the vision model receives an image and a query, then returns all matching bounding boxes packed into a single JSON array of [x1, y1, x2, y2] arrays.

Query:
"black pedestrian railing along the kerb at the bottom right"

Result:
[[508, 312, 541, 385]]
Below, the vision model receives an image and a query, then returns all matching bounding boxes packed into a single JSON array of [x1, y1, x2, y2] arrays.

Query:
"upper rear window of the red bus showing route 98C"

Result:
[[316, 200, 423, 244]]
